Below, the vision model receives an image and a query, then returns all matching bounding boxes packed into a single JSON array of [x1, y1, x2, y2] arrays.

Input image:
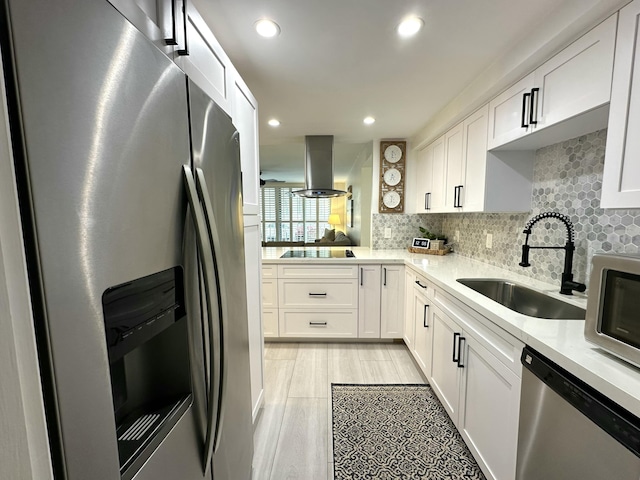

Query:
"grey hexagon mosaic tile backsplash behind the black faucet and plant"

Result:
[[373, 130, 640, 285]]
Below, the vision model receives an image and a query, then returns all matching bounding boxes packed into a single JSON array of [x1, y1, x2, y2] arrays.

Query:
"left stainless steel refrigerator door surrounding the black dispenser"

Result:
[[0, 0, 211, 480]]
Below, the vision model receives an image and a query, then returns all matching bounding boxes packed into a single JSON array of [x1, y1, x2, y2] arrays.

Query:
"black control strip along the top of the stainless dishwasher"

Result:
[[520, 346, 640, 457]]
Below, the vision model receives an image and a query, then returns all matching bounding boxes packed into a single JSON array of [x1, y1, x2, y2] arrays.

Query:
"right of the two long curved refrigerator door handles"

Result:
[[196, 168, 229, 458]]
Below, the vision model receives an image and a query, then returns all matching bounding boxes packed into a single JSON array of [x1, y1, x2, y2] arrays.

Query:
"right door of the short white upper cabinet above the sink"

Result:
[[534, 15, 617, 129]]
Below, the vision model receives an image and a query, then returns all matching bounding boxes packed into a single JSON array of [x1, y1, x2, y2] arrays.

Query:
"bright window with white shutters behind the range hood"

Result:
[[260, 186, 331, 243]]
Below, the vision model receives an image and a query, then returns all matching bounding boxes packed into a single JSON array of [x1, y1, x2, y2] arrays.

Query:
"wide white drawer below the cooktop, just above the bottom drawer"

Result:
[[278, 279, 358, 309]]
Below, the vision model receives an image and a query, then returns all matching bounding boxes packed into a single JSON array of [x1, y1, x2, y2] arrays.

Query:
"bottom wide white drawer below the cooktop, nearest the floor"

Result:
[[279, 310, 358, 338]]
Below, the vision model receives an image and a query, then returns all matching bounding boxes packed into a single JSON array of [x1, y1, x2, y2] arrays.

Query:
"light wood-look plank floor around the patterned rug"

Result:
[[253, 343, 424, 480]]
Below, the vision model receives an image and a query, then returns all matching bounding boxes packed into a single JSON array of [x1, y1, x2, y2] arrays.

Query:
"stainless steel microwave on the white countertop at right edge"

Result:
[[584, 254, 640, 367]]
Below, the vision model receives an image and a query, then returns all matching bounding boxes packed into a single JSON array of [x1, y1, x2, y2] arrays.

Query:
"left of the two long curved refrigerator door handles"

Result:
[[182, 165, 220, 473]]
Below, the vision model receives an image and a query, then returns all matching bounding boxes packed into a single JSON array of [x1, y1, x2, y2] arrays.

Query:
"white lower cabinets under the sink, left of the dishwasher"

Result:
[[405, 269, 524, 480]]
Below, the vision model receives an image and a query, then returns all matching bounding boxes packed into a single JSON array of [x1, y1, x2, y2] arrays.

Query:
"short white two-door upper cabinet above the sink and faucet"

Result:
[[488, 14, 617, 150]]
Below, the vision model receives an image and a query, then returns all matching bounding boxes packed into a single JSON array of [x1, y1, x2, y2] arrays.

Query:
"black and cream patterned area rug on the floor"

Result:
[[331, 384, 485, 480]]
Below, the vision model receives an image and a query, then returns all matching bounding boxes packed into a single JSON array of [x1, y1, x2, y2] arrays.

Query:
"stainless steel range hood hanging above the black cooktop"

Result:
[[292, 135, 347, 198]]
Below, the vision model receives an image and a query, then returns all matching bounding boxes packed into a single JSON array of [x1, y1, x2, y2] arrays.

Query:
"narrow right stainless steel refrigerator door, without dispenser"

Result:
[[188, 80, 253, 480]]
